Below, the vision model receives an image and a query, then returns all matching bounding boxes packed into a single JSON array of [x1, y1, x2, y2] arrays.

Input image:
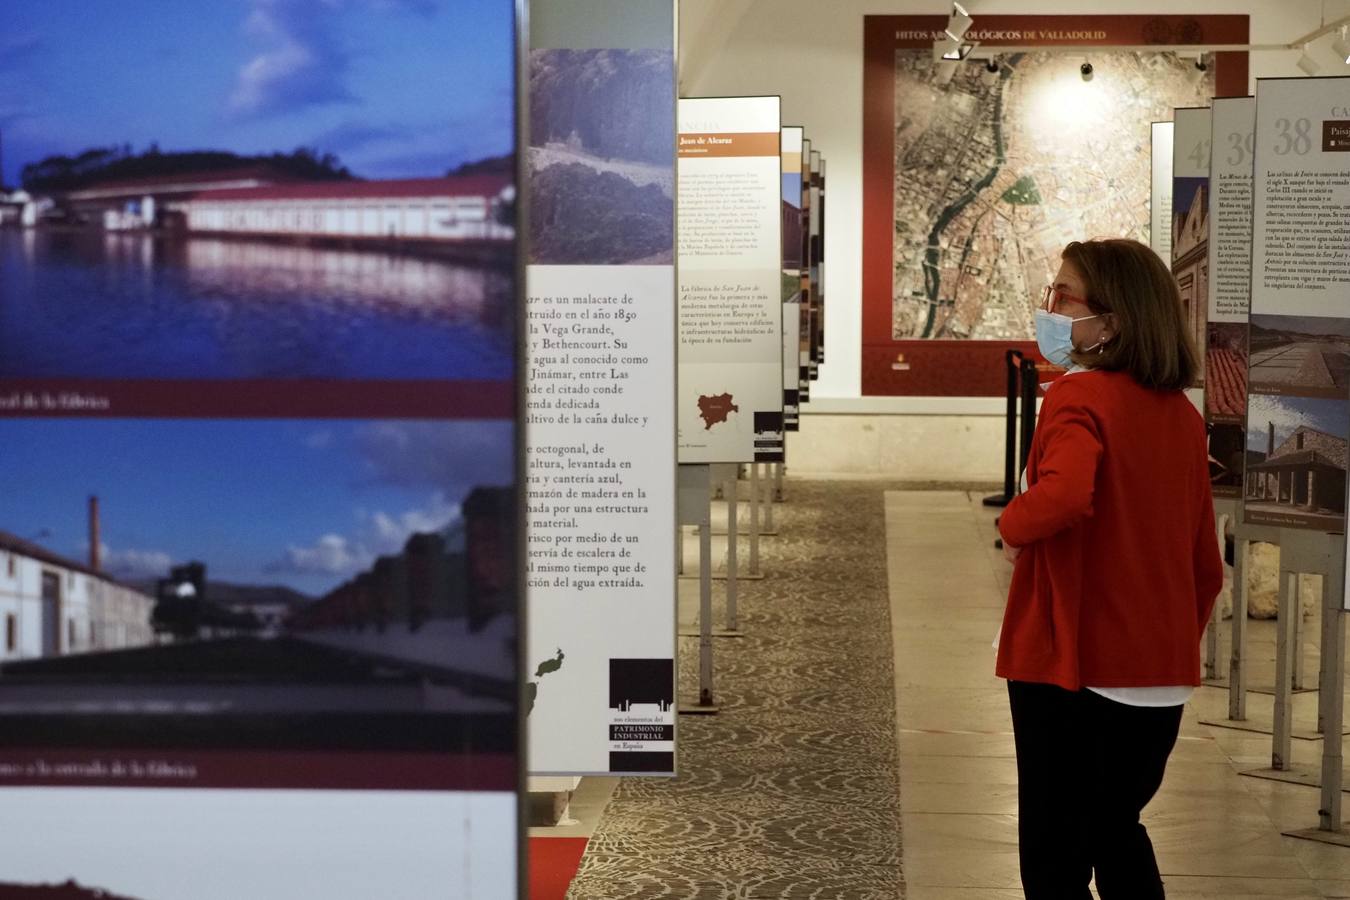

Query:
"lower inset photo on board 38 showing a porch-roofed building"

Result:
[[1243, 394, 1350, 530]]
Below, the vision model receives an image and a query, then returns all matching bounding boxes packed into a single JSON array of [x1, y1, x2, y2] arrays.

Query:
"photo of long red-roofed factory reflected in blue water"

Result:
[[0, 0, 517, 381]]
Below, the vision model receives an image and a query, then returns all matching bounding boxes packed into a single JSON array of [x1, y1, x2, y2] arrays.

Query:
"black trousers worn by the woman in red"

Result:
[[1008, 681, 1181, 900]]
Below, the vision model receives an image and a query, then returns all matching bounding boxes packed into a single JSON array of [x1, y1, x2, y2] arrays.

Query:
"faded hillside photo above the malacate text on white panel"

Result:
[[529, 49, 675, 266]]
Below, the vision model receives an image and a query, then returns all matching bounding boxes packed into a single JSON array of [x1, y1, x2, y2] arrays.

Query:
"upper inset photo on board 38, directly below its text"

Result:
[[1249, 316, 1350, 397]]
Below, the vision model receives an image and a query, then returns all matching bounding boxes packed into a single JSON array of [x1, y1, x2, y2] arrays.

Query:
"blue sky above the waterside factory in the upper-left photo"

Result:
[[0, 0, 514, 186]]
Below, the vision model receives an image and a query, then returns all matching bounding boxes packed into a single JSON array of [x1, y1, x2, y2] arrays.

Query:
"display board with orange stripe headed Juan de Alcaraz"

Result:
[[678, 97, 783, 464]]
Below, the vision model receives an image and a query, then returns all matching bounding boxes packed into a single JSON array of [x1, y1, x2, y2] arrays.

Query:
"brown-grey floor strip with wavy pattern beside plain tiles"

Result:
[[567, 480, 903, 900]]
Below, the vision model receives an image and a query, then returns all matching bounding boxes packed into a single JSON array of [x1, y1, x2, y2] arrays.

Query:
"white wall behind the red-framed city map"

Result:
[[679, 0, 1350, 480]]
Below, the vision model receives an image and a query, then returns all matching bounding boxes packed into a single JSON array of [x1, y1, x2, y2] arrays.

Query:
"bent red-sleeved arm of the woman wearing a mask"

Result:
[[999, 378, 1102, 546]]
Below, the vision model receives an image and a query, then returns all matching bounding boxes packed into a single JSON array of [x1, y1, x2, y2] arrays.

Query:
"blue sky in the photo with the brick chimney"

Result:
[[0, 418, 513, 595]]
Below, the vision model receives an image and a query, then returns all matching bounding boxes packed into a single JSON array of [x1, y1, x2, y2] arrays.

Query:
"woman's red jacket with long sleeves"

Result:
[[996, 371, 1223, 691]]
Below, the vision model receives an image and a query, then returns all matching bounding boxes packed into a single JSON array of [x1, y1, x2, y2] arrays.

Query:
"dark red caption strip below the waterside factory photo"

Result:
[[0, 379, 516, 418]]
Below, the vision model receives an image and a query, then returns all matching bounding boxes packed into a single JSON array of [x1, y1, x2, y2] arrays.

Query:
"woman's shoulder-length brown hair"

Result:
[[1061, 237, 1204, 390]]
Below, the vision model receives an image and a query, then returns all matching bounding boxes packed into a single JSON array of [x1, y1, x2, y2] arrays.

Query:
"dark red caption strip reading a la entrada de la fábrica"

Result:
[[0, 749, 518, 791]]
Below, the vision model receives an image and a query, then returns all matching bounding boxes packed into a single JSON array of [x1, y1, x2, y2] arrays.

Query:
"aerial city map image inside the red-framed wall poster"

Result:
[[891, 49, 1214, 341]]
